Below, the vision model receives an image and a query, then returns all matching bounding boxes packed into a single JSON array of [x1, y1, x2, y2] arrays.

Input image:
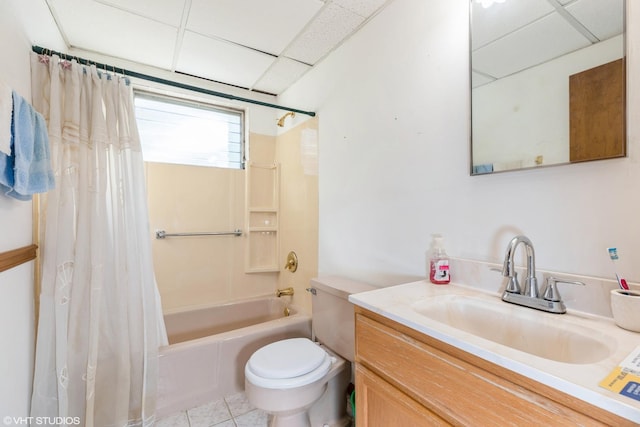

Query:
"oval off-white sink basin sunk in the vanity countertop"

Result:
[[411, 295, 610, 364]]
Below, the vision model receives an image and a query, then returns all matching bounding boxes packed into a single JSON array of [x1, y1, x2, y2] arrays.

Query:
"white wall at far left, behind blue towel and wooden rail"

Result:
[[0, 2, 39, 418]]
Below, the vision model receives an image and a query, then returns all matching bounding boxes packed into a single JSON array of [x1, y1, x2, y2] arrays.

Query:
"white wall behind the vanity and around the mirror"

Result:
[[280, 0, 640, 289]]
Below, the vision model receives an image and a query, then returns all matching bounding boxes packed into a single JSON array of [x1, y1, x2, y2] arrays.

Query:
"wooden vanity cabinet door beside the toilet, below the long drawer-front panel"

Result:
[[356, 365, 449, 427]]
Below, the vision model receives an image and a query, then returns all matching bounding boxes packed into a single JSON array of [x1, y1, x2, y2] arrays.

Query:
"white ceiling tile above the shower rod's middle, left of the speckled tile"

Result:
[[176, 31, 275, 88]]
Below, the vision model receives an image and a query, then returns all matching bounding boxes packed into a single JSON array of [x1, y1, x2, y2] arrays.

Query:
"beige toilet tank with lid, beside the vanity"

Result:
[[311, 276, 376, 362]]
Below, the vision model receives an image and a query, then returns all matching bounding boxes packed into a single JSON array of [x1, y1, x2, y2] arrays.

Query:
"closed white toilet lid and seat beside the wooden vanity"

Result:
[[245, 338, 332, 389]]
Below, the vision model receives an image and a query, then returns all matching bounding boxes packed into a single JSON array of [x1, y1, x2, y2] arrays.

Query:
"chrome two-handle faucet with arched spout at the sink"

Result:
[[502, 236, 584, 314]]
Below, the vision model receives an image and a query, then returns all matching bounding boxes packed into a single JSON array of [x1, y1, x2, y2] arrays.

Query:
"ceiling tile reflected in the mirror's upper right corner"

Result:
[[566, 0, 624, 40]]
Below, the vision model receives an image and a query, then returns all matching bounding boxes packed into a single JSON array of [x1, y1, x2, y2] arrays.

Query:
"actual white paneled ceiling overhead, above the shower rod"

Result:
[[45, 0, 393, 95]]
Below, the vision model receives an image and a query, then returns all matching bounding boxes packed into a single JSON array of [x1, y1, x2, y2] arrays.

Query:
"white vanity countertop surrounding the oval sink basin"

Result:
[[349, 280, 640, 423]]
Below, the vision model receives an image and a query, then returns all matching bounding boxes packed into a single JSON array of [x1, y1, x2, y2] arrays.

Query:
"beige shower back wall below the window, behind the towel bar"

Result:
[[145, 132, 284, 312]]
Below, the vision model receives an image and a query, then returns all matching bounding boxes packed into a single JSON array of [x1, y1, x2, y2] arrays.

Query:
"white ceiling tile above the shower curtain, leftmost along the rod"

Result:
[[50, 0, 177, 69]]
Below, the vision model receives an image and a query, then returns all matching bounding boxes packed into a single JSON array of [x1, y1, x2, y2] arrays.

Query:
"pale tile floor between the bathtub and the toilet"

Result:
[[156, 392, 268, 427]]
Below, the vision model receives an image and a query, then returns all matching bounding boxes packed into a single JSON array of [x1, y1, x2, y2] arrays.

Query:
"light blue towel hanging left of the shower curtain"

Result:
[[0, 91, 55, 200]]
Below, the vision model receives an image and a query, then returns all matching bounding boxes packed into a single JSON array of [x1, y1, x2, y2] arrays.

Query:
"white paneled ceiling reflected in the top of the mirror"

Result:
[[471, 0, 624, 87]]
